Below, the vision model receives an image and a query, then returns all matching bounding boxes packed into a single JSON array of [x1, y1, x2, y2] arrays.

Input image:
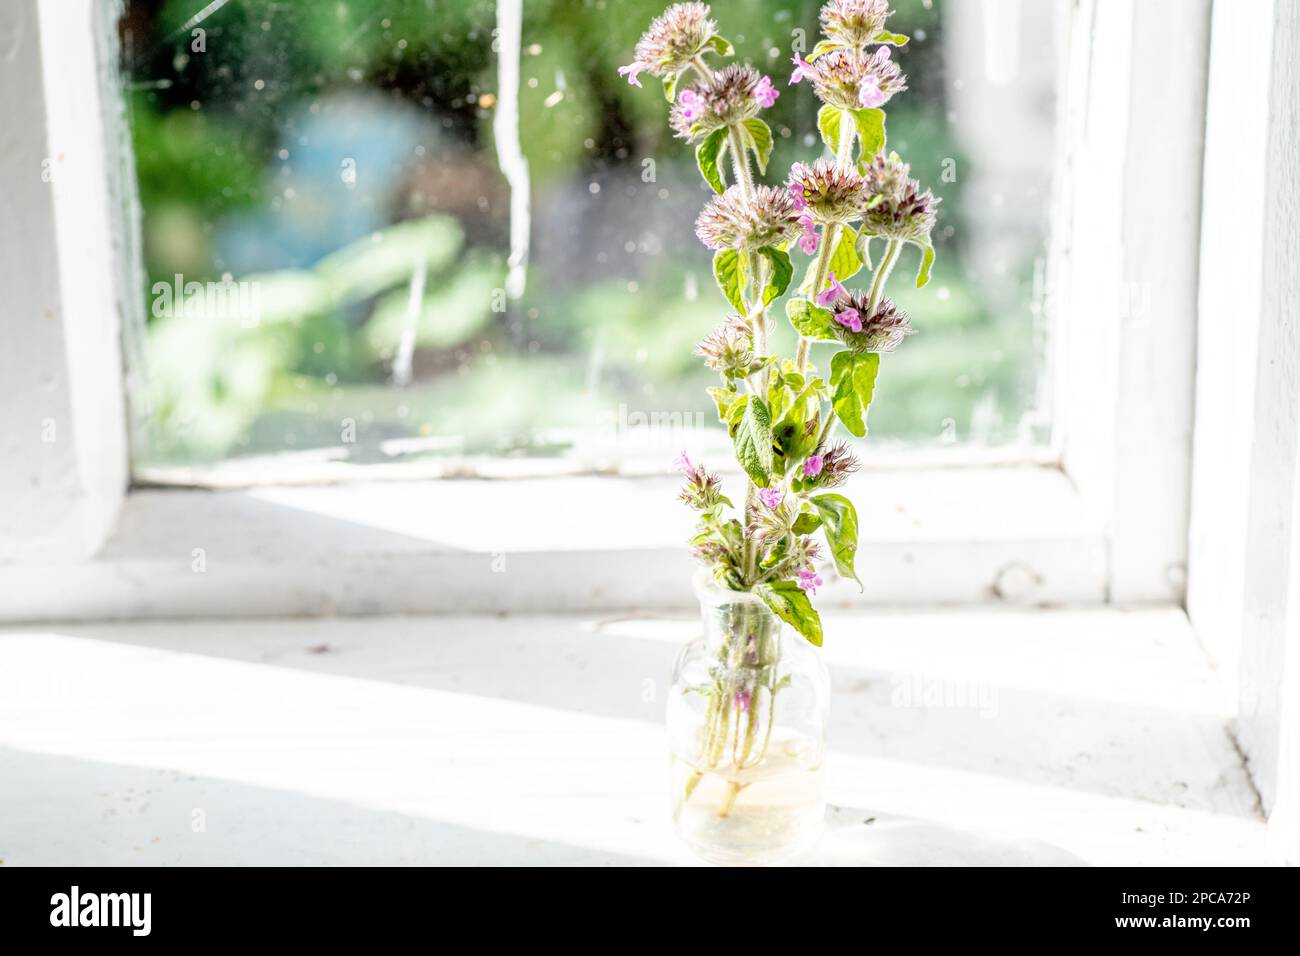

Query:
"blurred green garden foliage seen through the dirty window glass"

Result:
[[121, 0, 1036, 463]]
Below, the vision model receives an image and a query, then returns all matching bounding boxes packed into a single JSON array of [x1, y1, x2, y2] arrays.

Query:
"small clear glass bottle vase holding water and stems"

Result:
[[668, 571, 831, 865]]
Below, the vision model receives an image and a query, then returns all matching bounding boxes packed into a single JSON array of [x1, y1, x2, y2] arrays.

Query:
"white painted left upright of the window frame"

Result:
[[0, 0, 126, 562]]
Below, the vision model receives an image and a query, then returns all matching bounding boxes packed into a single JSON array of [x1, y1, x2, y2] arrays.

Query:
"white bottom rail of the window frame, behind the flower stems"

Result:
[[0, 467, 1105, 620]]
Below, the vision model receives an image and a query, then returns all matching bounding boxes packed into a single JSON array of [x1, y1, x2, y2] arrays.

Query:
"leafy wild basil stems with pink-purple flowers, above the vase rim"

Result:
[[619, 0, 939, 645]]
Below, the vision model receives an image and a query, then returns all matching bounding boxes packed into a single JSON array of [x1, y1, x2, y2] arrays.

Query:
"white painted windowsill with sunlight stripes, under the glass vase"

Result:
[[0, 610, 1265, 866]]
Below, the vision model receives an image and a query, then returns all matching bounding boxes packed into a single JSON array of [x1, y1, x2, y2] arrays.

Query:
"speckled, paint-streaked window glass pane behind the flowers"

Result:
[[121, 0, 1058, 479]]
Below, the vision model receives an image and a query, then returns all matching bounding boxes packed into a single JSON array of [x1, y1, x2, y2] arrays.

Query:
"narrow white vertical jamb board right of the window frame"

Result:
[[1187, 0, 1273, 679]]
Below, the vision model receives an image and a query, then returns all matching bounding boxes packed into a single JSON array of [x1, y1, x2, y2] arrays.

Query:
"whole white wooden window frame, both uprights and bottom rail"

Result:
[[0, 0, 1208, 620]]
